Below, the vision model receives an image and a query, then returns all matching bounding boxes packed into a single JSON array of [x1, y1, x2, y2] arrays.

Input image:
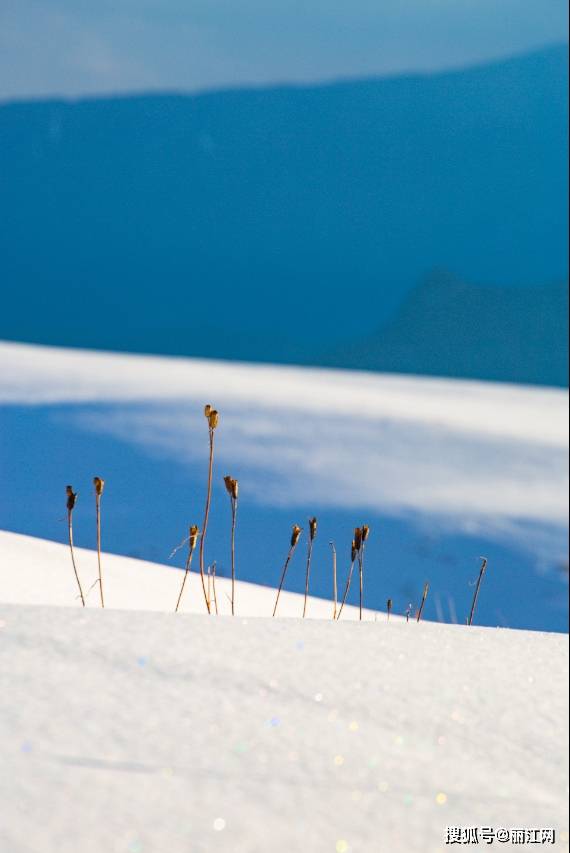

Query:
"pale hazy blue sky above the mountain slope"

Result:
[[0, 0, 568, 99]]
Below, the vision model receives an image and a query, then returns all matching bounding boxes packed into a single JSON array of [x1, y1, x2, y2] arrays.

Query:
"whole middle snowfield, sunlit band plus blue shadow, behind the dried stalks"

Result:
[[0, 343, 568, 631]]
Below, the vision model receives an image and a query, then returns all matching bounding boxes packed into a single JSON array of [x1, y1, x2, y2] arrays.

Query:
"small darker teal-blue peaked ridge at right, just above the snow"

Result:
[[323, 273, 569, 387]]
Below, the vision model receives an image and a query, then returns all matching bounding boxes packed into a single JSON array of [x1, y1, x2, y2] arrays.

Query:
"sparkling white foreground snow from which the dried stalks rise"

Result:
[[0, 533, 568, 853]]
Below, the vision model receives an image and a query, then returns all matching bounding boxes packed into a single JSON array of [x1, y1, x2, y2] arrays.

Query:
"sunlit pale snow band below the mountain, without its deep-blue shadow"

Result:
[[0, 343, 568, 532]]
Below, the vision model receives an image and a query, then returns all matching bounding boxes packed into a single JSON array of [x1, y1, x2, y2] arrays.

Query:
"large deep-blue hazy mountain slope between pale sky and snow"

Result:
[[0, 47, 568, 381]]
